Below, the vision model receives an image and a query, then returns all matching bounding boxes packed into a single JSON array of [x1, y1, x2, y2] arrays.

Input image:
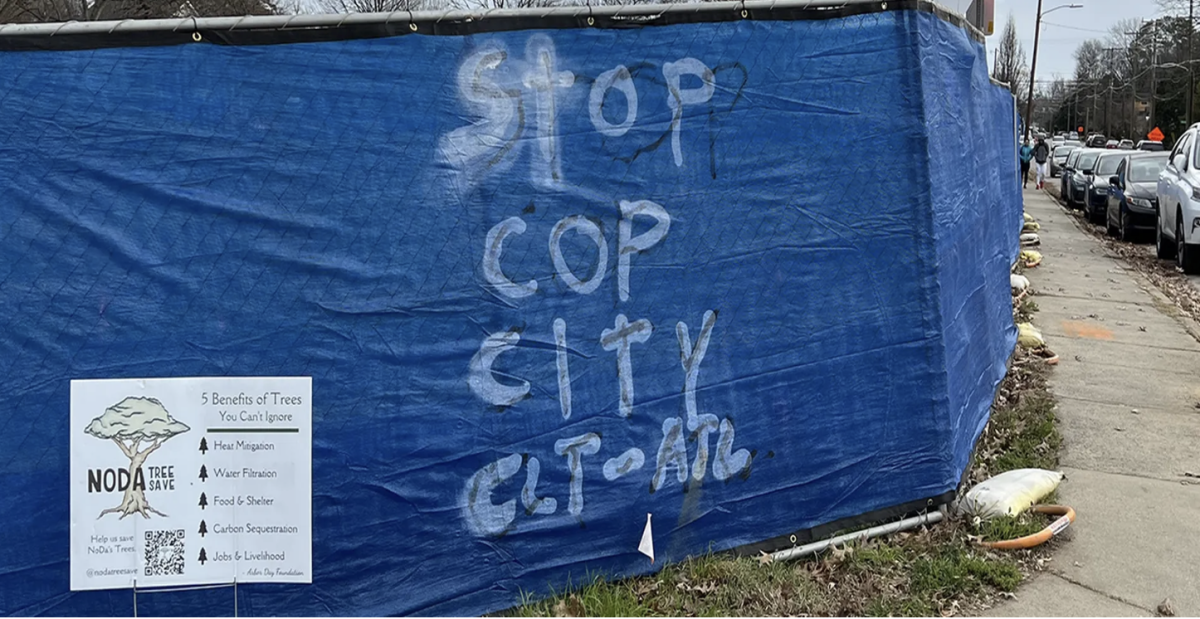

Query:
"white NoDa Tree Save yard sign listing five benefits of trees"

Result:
[[71, 377, 312, 590]]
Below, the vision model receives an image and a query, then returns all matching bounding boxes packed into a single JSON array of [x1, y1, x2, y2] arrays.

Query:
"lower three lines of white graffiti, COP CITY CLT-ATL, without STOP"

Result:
[[462, 211, 751, 535]]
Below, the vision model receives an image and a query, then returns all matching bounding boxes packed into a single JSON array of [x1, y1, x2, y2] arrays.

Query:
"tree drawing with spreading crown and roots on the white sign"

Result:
[[84, 397, 191, 519]]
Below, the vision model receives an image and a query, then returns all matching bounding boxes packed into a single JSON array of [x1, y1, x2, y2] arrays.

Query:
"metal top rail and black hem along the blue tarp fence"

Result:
[[0, 0, 983, 41]]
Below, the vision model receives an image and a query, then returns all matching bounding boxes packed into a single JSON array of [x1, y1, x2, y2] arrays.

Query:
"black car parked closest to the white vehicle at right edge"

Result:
[[1104, 152, 1169, 241]]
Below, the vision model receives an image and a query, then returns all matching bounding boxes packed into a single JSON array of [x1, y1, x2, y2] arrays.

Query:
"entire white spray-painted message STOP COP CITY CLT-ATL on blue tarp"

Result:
[[453, 35, 751, 536]]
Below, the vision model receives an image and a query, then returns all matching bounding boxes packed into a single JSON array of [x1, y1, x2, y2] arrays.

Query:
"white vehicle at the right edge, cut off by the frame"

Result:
[[1154, 124, 1200, 275]]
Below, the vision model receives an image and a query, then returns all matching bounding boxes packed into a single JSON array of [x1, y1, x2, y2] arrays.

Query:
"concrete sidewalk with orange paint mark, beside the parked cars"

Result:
[[990, 190, 1200, 617]]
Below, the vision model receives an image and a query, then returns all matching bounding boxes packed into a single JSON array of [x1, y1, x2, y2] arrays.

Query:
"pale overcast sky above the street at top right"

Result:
[[940, 0, 1159, 85]]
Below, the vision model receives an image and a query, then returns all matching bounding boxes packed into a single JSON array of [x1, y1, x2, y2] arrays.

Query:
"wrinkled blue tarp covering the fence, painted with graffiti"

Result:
[[0, 11, 1021, 615]]
